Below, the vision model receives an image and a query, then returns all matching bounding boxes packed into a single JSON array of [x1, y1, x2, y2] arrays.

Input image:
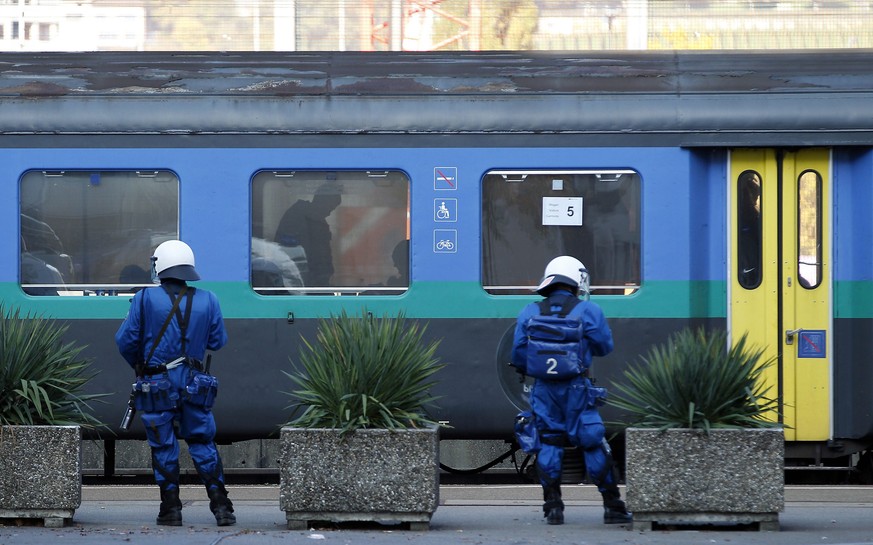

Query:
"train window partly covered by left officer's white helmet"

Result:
[[20, 170, 179, 295]]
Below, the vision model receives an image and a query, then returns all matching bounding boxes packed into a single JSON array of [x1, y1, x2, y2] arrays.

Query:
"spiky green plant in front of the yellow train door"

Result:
[[610, 328, 781, 431]]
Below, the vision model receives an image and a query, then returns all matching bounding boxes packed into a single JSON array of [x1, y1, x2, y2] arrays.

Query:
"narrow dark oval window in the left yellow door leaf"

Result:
[[737, 170, 763, 290]]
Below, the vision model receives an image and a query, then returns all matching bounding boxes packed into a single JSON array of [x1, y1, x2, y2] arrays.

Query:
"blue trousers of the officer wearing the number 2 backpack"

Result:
[[530, 376, 616, 493]]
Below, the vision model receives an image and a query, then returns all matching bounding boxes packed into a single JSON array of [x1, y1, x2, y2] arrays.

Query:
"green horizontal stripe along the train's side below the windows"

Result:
[[0, 282, 724, 321]]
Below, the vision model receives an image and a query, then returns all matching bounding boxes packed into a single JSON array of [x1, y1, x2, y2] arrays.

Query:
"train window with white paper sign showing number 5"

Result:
[[482, 170, 641, 295]]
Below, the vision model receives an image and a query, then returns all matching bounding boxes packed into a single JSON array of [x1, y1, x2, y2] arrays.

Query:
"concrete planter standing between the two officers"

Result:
[[279, 427, 439, 530]]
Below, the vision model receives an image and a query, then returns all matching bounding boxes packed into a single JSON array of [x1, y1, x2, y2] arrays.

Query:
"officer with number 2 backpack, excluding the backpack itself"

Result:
[[511, 256, 632, 524]]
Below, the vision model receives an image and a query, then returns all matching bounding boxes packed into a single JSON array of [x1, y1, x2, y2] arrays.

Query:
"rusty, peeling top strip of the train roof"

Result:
[[0, 51, 873, 97]]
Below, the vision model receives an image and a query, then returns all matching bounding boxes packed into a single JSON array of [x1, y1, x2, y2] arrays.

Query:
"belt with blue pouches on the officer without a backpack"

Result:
[[134, 357, 218, 412]]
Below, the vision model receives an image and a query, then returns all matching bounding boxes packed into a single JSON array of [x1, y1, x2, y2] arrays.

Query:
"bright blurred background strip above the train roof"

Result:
[[0, 0, 873, 51]]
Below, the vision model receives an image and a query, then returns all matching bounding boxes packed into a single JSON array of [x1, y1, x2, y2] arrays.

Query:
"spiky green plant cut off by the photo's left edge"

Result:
[[0, 304, 107, 428]]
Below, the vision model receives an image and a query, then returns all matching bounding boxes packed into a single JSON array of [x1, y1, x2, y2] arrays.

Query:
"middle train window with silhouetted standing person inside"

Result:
[[251, 170, 409, 295]]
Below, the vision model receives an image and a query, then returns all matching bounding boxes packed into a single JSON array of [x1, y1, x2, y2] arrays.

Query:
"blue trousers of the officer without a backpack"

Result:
[[142, 366, 224, 489]]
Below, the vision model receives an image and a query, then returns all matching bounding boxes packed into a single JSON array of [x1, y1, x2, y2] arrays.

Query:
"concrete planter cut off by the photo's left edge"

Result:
[[0, 426, 82, 528]]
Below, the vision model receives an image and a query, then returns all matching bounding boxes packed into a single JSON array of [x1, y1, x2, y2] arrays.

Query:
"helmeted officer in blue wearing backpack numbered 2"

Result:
[[511, 255, 632, 524]]
